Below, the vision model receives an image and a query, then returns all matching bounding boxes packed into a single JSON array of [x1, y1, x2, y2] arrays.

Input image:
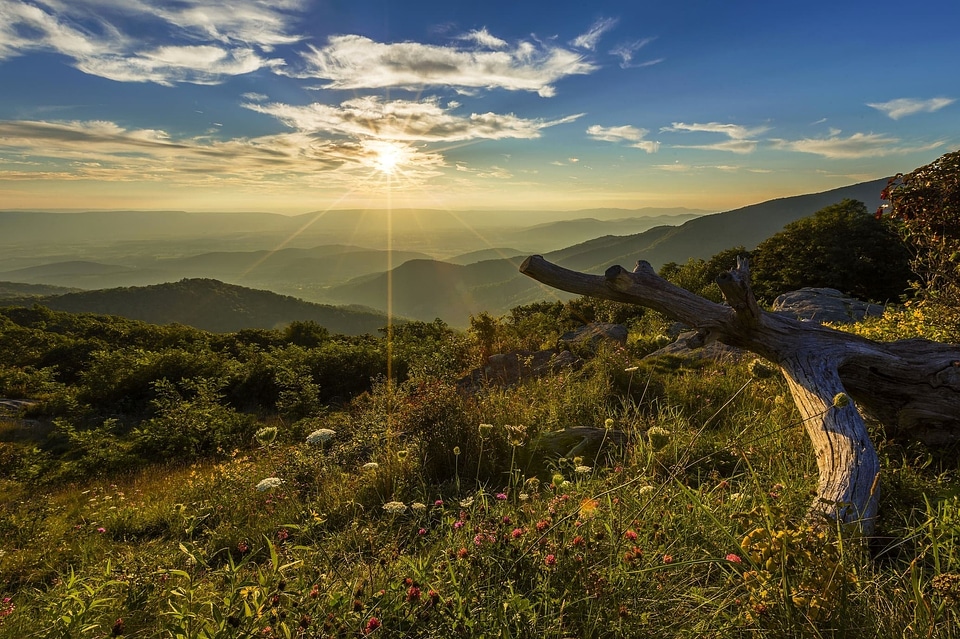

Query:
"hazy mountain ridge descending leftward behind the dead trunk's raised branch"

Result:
[[329, 178, 887, 326]]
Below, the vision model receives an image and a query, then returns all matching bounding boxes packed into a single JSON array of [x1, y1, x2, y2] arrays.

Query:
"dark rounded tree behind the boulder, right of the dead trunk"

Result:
[[750, 200, 911, 303]]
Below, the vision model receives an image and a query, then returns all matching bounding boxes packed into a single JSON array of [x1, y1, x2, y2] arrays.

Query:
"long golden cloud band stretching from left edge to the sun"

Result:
[[0, 121, 445, 189]]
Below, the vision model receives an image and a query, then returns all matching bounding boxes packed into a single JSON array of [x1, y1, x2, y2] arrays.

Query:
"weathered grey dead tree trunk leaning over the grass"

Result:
[[520, 255, 960, 534]]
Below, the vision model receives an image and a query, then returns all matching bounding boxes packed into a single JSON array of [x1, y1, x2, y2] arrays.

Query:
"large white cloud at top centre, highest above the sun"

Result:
[[296, 34, 598, 97]]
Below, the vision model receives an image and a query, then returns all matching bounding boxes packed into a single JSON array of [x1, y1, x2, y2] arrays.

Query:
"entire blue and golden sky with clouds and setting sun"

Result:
[[0, 0, 960, 214]]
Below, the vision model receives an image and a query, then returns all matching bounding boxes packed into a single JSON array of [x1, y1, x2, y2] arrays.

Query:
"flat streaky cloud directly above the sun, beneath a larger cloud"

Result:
[[244, 96, 583, 142]]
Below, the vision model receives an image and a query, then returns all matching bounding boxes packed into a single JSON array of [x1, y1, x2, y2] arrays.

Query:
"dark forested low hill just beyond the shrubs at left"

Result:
[[0, 279, 387, 335]]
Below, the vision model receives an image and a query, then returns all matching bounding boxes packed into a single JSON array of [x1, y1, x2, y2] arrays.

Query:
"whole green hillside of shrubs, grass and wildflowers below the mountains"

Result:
[[0, 292, 960, 639]]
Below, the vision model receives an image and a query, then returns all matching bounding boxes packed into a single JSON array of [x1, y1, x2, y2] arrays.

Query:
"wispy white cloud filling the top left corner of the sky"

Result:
[[0, 0, 302, 85]]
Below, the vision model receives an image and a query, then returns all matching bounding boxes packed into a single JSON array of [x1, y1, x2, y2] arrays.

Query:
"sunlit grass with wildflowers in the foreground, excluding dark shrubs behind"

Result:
[[0, 340, 960, 639]]
